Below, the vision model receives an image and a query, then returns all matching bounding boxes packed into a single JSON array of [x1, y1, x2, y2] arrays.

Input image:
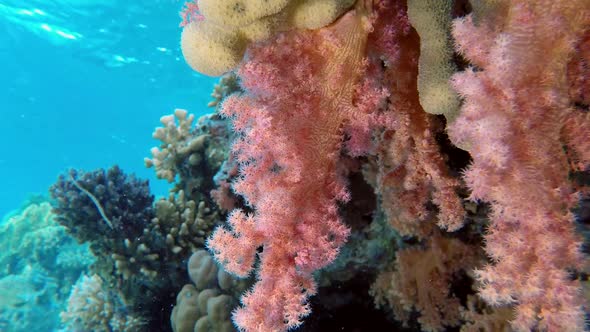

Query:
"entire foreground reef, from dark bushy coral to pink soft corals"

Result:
[[44, 0, 590, 332]]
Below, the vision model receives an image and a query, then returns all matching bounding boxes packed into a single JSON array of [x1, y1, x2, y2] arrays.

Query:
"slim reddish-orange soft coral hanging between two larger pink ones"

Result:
[[371, 2, 465, 236]]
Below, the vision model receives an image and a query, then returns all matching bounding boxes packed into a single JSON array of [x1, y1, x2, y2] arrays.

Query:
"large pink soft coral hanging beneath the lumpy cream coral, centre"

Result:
[[208, 11, 381, 331]]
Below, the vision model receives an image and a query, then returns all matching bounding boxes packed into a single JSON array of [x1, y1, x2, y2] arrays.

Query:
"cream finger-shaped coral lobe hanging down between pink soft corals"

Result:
[[408, 0, 459, 120]]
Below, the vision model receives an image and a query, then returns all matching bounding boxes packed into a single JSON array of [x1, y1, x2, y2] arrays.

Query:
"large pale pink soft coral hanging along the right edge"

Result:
[[449, 0, 590, 331]]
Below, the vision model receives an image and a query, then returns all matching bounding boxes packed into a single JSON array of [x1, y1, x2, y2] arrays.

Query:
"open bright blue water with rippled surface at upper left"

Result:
[[0, 0, 215, 216]]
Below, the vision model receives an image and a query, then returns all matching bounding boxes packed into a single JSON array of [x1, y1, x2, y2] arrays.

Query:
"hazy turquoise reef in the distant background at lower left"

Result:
[[0, 198, 94, 332]]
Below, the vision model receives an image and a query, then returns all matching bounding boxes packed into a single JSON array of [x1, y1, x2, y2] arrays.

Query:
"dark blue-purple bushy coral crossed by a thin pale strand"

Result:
[[50, 166, 185, 329]]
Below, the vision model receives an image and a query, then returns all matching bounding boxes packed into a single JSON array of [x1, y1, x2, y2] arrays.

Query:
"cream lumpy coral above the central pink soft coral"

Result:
[[180, 0, 354, 76]]
